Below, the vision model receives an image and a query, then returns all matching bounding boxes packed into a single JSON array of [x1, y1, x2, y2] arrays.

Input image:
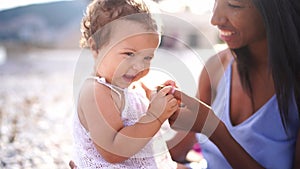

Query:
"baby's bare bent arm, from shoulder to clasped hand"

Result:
[[79, 81, 178, 163]]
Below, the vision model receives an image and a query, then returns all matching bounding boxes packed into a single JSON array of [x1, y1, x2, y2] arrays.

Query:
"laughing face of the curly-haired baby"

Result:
[[97, 21, 159, 88]]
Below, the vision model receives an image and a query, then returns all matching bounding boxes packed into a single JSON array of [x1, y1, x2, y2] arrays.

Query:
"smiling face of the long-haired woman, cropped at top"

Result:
[[211, 0, 266, 49]]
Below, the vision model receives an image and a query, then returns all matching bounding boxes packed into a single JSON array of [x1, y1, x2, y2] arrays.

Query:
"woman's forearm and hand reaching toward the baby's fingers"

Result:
[[169, 91, 263, 169]]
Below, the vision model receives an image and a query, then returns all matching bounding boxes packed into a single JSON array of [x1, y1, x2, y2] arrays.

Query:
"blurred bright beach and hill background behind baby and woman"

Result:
[[0, 0, 224, 169]]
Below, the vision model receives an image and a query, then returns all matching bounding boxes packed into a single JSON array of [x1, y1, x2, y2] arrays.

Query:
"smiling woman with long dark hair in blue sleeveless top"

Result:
[[170, 0, 300, 169]]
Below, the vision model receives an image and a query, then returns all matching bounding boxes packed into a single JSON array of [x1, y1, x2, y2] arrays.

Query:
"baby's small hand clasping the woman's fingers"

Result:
[[148, 86, 178, 123]]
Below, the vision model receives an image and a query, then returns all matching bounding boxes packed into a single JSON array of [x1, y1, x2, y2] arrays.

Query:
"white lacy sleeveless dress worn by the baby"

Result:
[[73, 79, 177, 169]]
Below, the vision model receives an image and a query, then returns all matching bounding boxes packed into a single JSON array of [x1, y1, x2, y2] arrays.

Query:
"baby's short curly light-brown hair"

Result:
[[80, 0, 157, 48]]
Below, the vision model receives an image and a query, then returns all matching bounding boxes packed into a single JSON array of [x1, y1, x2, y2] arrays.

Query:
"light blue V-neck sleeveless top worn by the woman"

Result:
[[197, 60, 300, 169]]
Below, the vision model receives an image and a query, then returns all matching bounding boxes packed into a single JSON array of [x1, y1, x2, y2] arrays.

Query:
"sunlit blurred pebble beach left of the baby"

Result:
[[0, 49, 80, 169]]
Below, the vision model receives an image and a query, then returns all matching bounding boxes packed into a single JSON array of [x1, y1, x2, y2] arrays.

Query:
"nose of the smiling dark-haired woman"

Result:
[[210, 0, 227, 26]]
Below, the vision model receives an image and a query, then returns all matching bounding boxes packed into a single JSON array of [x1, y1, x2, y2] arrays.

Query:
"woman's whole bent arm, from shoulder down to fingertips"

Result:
[[169, 49, 263, 169]]
